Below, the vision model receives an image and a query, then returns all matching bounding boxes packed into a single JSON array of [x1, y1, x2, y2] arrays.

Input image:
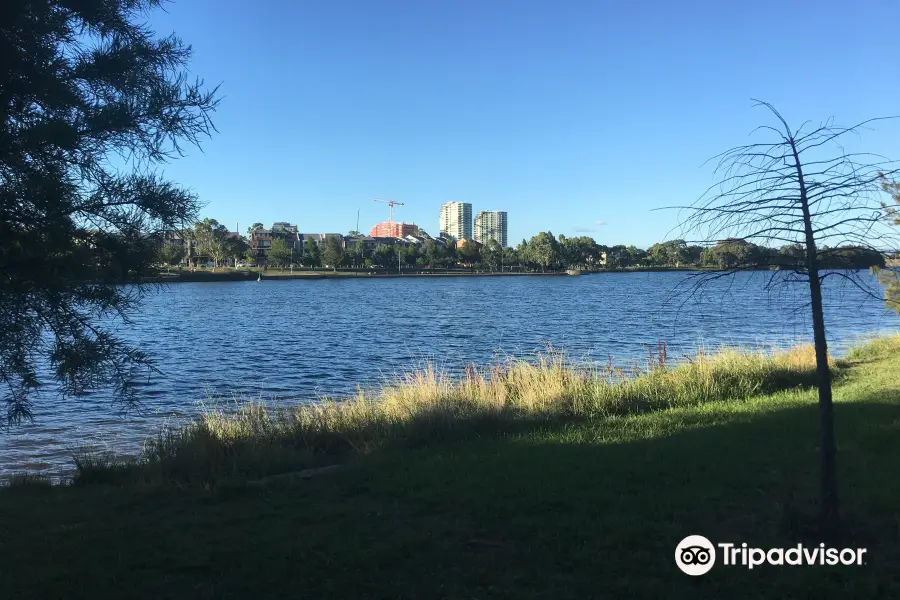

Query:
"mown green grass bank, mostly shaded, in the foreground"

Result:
[[0, 338, 900, 599]]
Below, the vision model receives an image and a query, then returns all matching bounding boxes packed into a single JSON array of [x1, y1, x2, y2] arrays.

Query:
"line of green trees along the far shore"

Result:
[[160, 224, 885, 272]]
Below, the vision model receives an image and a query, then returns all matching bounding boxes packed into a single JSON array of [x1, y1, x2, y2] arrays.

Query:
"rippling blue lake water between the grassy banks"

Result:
[[0, 272, 900, 473]]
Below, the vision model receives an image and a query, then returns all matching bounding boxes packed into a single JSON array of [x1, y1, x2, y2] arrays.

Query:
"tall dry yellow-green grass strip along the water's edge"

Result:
[[76, 346, 844, 481]]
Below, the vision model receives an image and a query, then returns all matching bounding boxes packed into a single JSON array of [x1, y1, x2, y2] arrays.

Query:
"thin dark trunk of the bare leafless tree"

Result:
[[791, 140, 841, 539]]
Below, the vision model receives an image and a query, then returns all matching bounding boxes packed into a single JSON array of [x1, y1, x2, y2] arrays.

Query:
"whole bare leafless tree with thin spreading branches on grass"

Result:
[[677, 101, 900, 537]]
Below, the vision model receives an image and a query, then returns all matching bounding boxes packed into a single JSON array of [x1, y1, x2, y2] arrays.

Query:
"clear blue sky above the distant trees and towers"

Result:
[[150, 0, 900, 247]]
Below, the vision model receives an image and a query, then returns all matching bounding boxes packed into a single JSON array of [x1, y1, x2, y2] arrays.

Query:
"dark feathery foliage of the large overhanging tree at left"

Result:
[[0, 0, 217, 422]]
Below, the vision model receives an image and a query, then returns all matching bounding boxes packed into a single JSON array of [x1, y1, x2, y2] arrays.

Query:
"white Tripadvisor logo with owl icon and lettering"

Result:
[[675, 535, 866, 576]]
